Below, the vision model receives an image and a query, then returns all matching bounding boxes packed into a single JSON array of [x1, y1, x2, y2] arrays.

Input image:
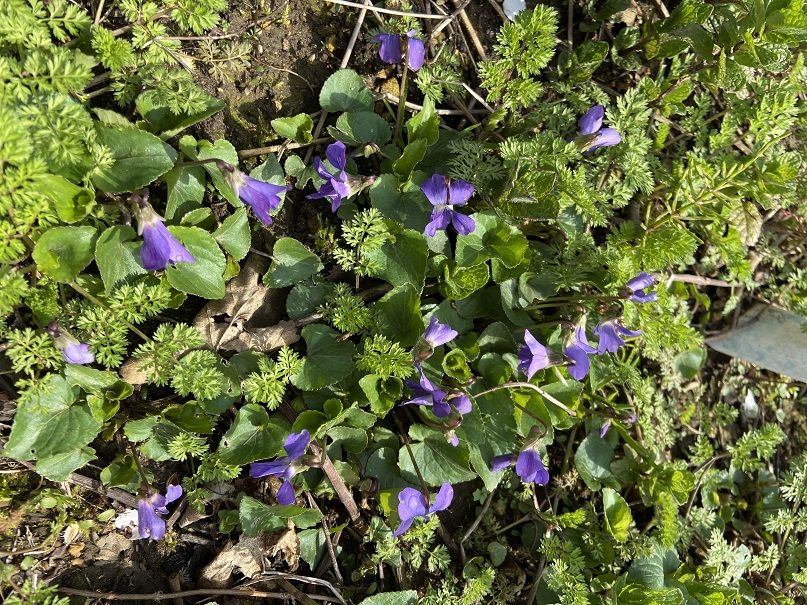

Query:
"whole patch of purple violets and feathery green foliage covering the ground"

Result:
[[0, 0, 807, 605]]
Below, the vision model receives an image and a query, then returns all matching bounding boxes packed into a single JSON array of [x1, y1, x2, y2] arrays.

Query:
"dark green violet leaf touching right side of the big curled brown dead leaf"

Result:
[[291, 324, 356, 391]]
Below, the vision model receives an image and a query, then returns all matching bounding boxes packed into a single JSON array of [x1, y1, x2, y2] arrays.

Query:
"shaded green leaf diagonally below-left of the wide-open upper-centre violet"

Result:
[[367, 225, 429, 292]]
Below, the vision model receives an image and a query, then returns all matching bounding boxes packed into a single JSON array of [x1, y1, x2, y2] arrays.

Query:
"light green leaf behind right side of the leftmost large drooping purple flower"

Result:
[[165, 227, 227, 299]]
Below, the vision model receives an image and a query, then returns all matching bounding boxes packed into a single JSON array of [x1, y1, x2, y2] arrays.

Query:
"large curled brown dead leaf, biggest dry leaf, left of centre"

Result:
[[193, 256, 300, 352]]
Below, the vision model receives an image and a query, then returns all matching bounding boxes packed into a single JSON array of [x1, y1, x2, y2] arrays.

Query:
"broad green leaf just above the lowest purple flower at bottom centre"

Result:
[[398, 427, 476, 486]]
